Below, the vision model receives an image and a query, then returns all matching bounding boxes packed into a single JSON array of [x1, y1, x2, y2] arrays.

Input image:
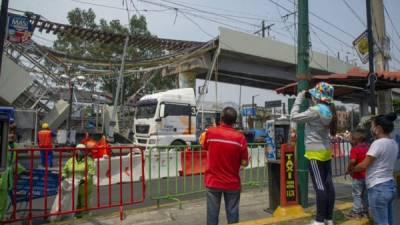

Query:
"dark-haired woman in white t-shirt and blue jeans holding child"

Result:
[[352, 113, 400, 225]]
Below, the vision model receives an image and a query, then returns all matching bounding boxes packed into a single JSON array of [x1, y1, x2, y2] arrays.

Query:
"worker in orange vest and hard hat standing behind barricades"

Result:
[[38, 123, 54, 167]]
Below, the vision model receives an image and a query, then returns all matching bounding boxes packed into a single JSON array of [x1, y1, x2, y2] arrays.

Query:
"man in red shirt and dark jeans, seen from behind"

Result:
[[203, 107, 248, 225]]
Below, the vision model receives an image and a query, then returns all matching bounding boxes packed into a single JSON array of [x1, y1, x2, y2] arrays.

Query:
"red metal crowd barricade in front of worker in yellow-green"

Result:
[[0, 146, 146, 223]]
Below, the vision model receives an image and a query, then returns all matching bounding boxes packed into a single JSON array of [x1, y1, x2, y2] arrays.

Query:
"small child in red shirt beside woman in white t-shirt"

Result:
[[346, 129, 369, 218]]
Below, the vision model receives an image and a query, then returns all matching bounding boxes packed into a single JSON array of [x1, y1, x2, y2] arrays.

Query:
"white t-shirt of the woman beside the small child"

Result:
[[366, 138, 399, 188]]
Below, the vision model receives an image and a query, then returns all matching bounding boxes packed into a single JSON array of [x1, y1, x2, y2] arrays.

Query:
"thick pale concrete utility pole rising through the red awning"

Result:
[[371, 0, 393, 114]]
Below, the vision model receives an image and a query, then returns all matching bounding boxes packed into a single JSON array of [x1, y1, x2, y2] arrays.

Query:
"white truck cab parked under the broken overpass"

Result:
[[134, 88, 196, 147]]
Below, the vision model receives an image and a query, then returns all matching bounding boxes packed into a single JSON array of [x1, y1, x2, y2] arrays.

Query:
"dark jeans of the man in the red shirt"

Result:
[[207, 188, 240, 225]]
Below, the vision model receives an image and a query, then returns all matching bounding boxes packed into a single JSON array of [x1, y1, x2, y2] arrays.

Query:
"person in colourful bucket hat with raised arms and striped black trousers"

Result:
[[290, 82, 337, 225]]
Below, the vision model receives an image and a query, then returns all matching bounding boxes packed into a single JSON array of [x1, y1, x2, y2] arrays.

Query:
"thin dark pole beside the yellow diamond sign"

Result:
[[366, 0, 376, 115]]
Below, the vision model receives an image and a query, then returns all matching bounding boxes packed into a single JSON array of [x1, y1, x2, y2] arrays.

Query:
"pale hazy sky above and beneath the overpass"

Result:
[[9, 0, 400, 108]]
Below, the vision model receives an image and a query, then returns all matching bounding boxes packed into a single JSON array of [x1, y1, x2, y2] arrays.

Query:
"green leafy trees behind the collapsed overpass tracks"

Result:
[[53, 8, 175, 101]]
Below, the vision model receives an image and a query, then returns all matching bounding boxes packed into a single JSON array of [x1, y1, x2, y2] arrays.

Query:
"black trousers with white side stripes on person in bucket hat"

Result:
[[309, 160, 335, 223]]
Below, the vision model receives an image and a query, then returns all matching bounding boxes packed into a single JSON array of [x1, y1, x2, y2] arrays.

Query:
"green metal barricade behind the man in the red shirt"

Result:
[[145, 144, 267, 208]]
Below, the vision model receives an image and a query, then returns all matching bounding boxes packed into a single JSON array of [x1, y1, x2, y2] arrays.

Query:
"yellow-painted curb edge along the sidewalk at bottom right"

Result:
[[236, 202, 352, 225]]
